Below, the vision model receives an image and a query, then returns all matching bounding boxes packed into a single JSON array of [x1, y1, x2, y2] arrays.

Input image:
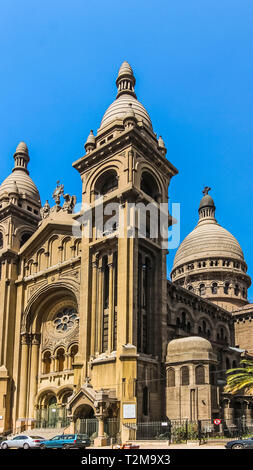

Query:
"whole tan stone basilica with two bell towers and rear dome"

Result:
[[0, 62, 253, 446]]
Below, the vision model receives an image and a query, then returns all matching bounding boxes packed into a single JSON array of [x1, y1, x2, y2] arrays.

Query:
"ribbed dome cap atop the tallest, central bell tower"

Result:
[[100, 94, 152, 129]]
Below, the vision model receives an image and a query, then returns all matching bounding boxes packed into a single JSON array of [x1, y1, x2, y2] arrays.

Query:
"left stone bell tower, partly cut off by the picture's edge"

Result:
[[0, 142, 41, 432]]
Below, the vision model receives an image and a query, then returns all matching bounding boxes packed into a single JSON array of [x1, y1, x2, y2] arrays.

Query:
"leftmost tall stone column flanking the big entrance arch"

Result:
[[18, 333, 30, 421]]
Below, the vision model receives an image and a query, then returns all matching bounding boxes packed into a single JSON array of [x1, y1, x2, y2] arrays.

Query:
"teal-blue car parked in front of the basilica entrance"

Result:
[[40, 434, 90, 449]]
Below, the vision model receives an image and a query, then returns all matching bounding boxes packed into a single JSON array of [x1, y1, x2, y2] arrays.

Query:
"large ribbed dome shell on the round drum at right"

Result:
[[173, 220, 244, 269]]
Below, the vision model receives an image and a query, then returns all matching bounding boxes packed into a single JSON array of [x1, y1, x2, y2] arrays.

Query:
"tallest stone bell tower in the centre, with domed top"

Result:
[[73, 62, 177, 422]]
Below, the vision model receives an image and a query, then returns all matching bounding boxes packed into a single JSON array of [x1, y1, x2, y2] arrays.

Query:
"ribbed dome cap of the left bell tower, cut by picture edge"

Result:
[[0, 170, 40, 202]]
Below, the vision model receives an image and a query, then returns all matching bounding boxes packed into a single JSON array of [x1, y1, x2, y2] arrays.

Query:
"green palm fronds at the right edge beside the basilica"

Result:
[[224, 359, 253, 395]]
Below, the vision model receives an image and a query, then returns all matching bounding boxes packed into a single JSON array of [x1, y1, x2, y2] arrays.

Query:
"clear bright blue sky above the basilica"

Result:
[[0, 0, 253, 301]]
